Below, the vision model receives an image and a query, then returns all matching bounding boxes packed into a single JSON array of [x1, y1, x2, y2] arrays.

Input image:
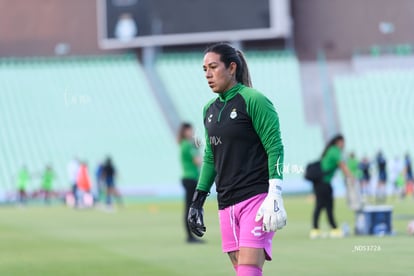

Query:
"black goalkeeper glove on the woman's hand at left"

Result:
[[187, 190, 208, 237]]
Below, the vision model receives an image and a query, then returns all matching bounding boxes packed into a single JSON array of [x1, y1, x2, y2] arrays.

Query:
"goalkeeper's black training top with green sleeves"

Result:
[[197, 84, 283, 209]]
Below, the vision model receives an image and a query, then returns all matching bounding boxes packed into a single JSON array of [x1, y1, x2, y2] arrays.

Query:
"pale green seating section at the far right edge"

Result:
[[334, 70, 414, 158]]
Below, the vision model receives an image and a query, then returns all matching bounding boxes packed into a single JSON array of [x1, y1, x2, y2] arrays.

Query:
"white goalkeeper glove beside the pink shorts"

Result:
[[256, 179, 287, 232]]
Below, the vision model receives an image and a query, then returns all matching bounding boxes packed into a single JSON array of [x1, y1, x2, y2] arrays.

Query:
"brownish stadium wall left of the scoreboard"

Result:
[[0, 0, 115, 57]]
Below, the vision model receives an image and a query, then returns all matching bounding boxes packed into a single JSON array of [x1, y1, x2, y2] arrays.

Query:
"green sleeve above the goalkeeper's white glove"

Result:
[[240, 87, 284, 179]]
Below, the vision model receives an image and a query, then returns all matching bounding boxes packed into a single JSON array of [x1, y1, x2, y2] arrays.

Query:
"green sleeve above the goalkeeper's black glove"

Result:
[[197, 99, 216, 192]]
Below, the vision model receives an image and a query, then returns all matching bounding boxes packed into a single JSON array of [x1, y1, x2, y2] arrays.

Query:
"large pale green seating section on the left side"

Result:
[[0, 55, 179, 196]]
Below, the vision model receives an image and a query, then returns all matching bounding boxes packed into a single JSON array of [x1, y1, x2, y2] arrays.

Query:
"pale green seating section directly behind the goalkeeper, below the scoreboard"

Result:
[[156, 51, 323, 178]]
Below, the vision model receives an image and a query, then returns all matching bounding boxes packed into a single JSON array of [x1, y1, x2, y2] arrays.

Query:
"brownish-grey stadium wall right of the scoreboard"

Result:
[[292, 0, 414, 60]]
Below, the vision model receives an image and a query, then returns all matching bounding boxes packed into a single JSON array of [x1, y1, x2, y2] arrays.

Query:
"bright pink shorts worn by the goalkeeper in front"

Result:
[[219, 194, 275, 260]]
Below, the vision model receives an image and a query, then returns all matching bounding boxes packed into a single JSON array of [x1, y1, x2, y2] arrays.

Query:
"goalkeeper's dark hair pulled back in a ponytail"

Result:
[[204, 42, 252, 87]]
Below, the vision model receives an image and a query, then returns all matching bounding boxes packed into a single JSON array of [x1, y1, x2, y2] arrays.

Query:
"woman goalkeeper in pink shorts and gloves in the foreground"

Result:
[[188, 43, 287, 276]]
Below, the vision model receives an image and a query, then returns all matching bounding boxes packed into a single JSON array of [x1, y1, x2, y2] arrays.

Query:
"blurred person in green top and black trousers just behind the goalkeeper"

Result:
[[178, 123, 201, 243]]
